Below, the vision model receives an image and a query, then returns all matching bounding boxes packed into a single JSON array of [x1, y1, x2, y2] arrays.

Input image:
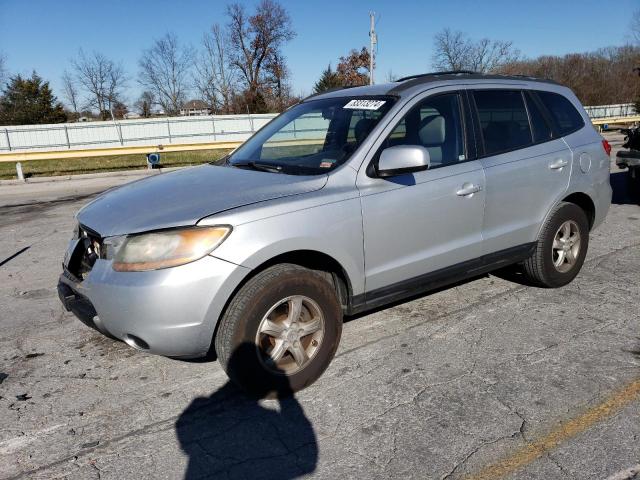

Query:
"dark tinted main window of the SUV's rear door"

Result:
[[473, 90, 533, 155]]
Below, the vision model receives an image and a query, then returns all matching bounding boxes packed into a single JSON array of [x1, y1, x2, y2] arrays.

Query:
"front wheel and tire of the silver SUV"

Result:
[[215, 264, 342, 398]]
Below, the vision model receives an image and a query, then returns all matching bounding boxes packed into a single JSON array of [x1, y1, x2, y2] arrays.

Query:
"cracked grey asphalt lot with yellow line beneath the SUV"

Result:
[[0, 137, 640, 479]]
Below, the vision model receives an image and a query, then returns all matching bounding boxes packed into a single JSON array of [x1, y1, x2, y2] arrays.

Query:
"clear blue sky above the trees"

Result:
[[0, 0, 640, 107]]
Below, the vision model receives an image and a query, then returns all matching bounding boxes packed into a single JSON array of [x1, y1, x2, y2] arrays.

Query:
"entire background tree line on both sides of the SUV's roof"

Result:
[[0, 5, 640, 125]]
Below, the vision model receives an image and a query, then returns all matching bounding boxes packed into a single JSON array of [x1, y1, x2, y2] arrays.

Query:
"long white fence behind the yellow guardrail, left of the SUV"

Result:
[[0, 114, 276, 153]]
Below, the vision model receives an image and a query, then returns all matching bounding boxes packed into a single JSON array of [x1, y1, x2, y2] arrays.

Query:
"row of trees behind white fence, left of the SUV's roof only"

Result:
[[0, 0, 299, 125]]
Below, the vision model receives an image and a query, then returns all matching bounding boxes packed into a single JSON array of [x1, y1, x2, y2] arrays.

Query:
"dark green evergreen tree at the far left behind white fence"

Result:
[[0, 72, 67, 125]]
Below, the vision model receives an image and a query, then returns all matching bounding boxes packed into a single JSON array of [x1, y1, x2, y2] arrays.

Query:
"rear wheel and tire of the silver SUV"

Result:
[[523, 202, 589, 288]]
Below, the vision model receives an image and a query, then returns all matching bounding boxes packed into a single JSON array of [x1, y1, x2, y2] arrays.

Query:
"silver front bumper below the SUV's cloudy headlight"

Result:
[[58, 256, 249, 358]]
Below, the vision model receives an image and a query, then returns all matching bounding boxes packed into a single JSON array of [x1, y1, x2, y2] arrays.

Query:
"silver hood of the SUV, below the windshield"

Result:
[[77, 164, 328, 237]]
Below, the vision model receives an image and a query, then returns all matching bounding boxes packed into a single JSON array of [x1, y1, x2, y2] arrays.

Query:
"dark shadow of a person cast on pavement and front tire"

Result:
[[176, 343, 318, 480]]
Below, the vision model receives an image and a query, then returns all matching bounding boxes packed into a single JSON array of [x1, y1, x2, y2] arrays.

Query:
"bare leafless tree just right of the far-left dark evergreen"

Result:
[[71, 50, 127, 120]]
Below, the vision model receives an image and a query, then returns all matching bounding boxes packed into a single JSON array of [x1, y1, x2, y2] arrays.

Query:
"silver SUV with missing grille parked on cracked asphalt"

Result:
[[58, 72, 611, 393]]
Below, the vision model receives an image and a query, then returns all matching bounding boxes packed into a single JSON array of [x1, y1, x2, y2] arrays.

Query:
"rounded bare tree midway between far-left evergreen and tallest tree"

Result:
[[138, 33, 193, 115]]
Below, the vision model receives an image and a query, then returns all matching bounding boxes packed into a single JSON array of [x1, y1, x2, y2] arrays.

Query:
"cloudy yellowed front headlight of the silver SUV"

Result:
[[113, 226, 231, 272]]
